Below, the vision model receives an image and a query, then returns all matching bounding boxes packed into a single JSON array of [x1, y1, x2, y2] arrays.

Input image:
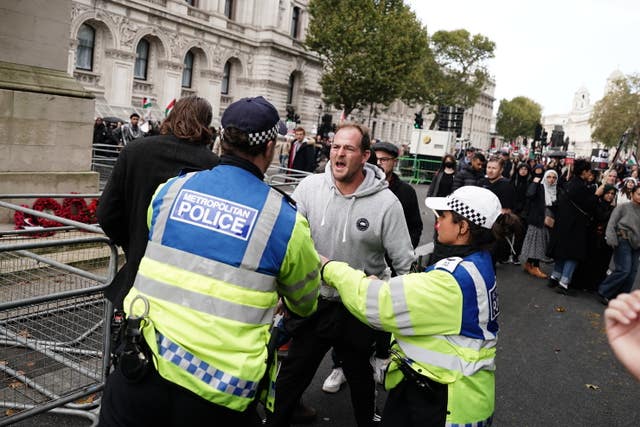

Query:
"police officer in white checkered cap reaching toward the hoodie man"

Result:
[[321, 187, 506, 427]]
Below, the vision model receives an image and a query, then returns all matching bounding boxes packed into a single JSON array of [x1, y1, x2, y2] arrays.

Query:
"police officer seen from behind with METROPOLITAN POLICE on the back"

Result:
[[100, 97, 319, 426]]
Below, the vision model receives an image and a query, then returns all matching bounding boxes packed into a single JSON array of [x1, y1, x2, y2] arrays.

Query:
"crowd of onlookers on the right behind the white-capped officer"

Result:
[[429, 148, 640, 304]]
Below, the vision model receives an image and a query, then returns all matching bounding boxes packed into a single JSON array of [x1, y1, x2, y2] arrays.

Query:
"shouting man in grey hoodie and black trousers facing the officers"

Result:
[[269, 123, 415, 427]]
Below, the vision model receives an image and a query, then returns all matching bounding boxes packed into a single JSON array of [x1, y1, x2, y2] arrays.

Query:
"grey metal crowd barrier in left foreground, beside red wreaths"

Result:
[[0, 194, 118, 426]]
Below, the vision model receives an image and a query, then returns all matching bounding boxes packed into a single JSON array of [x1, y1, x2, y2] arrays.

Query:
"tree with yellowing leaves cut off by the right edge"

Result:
[[589, 74, 640, 158]]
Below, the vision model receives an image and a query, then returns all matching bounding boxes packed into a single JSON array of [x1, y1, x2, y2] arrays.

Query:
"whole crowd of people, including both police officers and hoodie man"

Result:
[[96, 97, 640, 427]]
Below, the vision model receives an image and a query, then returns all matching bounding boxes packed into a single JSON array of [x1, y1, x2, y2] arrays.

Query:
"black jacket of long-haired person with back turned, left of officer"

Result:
[[97, 135, 219, 308]]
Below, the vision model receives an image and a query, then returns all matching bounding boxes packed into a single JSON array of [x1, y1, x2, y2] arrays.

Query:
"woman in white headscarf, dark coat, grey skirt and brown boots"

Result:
[[520, 165, 558, 279]]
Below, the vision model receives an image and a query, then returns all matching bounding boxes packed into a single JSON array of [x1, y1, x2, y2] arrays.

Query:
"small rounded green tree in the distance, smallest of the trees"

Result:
[[496, 96, 542, 141]]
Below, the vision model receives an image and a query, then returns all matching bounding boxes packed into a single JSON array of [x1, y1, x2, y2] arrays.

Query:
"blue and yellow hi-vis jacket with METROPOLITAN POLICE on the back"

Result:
[[125, 165, 319, 410]]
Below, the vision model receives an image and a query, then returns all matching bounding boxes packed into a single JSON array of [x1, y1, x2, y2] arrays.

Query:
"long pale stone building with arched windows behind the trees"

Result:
[[68, 0, 493, 146]]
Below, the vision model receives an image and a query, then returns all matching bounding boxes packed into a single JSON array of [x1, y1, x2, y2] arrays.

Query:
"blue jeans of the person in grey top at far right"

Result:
[[598, 238, 640, 299]]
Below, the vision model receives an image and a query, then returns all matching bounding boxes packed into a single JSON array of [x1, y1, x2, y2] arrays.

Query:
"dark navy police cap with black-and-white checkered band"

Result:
[[220, 96, 286, 145]]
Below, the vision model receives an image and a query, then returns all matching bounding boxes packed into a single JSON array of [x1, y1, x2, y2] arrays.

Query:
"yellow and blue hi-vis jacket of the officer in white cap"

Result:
[[323, 252, 498, 427]]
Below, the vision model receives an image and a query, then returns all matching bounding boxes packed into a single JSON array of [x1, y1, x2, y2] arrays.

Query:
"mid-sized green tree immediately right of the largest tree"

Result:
[[403, 29, 495, 129]]
